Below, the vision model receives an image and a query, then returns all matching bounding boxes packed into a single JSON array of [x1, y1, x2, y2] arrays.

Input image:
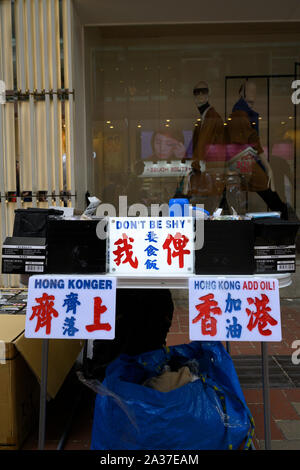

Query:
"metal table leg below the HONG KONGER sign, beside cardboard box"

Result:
[[38, 339, 49, 450]]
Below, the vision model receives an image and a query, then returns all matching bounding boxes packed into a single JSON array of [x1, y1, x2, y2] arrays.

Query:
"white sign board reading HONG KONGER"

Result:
[[25, 275, 116, 340]]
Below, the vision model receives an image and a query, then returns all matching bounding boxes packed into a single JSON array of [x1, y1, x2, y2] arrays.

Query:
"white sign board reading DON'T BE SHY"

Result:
[[108, 217, 194, 276]]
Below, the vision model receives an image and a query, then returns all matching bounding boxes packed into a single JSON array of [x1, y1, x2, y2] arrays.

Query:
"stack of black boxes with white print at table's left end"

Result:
[[2, 237, 47, 274]]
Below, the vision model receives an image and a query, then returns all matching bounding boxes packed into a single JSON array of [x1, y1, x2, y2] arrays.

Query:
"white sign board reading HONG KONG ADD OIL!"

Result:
[[189, 277, 281, 342]]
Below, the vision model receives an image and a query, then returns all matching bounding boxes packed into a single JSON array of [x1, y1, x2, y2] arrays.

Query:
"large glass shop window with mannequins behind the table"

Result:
[[85, 25, 300, 219]]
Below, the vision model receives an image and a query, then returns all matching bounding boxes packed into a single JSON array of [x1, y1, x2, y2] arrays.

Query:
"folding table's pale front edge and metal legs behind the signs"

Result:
[[33, 274, 292, 450]]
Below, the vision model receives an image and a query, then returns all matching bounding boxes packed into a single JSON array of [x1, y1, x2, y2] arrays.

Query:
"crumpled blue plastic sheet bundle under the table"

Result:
[[91, 341, 254, 450]]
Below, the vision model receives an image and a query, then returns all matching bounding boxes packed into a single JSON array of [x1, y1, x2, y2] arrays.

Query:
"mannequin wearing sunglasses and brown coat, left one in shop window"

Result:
[[185, 81, 225, 211]]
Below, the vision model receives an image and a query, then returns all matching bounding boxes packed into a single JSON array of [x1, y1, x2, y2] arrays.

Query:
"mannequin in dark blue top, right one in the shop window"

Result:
[[226, 81, 287, 218]]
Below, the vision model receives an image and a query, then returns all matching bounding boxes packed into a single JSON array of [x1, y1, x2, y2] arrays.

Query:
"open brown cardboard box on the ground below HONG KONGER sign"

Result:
[[0, 314, 84, 450]]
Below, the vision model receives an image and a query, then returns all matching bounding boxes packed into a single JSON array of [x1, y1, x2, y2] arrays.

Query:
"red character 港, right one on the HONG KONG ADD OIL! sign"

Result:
[[246, 294, 278, 336]]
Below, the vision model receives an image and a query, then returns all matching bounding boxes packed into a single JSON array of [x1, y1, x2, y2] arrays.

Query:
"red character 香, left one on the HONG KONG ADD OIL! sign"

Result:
[[192, 294, 222, 336]]
